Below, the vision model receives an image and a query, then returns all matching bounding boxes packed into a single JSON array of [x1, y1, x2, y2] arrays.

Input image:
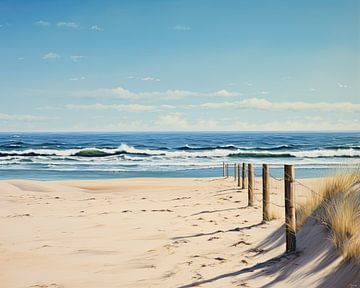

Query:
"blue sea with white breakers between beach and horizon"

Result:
[[0, 132, 360, 180]]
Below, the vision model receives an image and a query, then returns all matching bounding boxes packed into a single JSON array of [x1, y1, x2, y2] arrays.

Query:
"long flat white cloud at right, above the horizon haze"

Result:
[[198, 98, 360, 112]]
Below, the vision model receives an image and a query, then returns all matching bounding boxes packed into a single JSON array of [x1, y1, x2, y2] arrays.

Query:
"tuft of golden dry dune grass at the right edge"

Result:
[[296, 169, 360, 261]]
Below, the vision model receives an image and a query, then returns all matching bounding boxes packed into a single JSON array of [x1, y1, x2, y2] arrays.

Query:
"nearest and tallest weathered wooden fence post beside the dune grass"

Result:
[[284, 165, 296, 252]]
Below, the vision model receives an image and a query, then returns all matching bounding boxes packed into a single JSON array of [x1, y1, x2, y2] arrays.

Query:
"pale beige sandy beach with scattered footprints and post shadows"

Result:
[[0, 178, 360, 288]]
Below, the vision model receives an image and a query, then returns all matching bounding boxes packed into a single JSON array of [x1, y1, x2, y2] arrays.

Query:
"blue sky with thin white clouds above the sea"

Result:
[[0, 0, 360, 131]]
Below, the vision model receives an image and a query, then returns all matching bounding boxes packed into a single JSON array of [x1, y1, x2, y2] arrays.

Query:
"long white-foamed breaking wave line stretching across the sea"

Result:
[[0, 144, 360, 160]]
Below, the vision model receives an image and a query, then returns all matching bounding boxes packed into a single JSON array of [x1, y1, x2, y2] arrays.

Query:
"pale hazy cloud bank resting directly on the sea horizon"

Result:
[[65, 113, 360, 131]]
